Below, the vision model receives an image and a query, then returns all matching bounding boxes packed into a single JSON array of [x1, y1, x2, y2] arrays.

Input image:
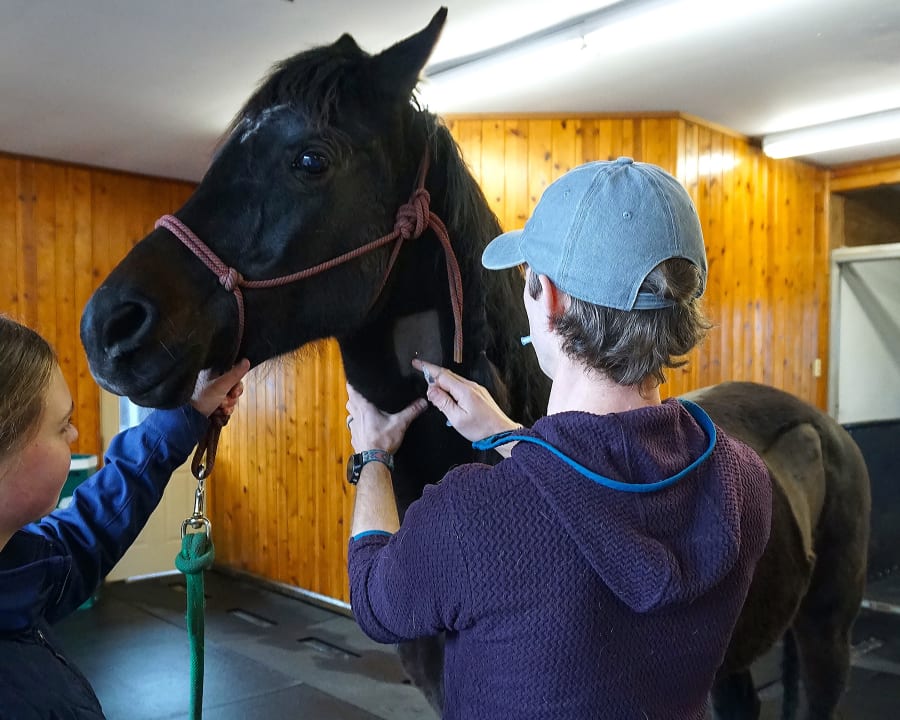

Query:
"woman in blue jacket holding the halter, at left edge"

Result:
[[0, 316, 249, 720]]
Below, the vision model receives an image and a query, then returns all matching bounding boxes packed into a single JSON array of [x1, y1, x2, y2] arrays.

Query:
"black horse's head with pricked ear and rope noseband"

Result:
[[81, 8, 458, 407]]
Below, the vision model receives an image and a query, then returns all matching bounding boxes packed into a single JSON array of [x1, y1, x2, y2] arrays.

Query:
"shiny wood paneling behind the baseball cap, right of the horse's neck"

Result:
[[451, 114, 828, 407]]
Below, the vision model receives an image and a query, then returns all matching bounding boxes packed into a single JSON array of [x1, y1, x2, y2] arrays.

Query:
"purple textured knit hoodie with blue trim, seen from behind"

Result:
[[349, 400, 771, 720]]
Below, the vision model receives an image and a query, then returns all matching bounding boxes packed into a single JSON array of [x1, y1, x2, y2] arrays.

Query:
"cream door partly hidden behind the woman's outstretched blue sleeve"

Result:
[[100, 390, 197, 581]]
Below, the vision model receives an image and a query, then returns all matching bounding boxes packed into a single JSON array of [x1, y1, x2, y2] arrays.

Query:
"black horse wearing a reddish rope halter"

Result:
[[81, 9, 869, 718]]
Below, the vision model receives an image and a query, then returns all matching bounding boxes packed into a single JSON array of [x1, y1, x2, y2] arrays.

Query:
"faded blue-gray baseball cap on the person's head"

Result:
[[481, 157, 707, 310]]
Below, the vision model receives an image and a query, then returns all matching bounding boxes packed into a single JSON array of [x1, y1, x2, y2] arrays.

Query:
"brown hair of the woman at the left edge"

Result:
[[0, 315, 57, 460]]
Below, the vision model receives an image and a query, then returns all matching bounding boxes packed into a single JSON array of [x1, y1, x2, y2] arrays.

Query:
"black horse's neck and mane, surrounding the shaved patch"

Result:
[[341, 116, 549, 423]]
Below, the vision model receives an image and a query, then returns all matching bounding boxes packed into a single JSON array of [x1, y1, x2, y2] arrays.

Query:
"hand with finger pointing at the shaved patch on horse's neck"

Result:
[[412, 358, 522, 442]]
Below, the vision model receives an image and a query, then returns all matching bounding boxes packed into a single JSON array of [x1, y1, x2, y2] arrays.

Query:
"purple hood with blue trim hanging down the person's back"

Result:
[[508, 399, 744, 612]]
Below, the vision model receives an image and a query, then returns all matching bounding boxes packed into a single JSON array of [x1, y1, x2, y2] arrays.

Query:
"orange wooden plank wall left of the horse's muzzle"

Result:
[[0, 154, 193, 453]]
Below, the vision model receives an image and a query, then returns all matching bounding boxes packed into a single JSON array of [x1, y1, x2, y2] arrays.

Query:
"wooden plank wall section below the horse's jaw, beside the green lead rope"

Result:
[[208, 340, 353, 601]]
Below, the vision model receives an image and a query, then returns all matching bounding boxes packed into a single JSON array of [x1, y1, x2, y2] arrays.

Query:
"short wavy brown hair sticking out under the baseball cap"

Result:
[[528, 258, 712, 385]]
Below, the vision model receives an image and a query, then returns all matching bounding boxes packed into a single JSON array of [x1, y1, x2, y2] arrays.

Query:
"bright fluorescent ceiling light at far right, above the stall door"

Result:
[[762, 108, 900, 158]]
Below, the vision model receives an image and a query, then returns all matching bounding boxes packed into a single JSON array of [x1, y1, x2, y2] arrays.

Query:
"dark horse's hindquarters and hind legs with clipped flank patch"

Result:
[[713, 422, 869, 720]]
